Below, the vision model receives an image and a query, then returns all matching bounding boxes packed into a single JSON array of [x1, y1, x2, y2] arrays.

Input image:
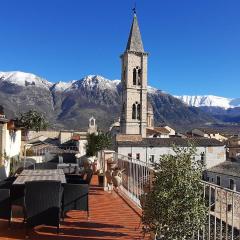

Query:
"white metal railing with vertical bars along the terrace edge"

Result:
[[104, 152, 240, 240]]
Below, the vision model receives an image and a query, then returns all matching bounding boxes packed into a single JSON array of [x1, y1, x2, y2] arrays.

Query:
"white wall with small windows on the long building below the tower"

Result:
[[118, 146, 226, 168]]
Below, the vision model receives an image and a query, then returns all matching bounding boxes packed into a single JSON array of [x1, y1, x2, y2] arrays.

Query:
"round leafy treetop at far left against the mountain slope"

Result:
[[19, 110, 48, 132]]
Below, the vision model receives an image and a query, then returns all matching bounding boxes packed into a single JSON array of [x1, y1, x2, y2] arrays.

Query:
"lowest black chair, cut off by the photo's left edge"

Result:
[[0, 189, 12, 227]]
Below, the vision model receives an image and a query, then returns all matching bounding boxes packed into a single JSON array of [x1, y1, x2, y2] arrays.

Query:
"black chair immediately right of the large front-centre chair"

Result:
[[62, 183, 89, 218]]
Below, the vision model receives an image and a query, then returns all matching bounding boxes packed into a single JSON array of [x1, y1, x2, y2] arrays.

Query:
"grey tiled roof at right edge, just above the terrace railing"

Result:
[[207, 161, 240, 177]]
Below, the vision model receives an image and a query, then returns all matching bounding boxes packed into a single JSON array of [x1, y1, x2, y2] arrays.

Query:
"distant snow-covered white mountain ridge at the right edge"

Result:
[[175, 95, 240, 109]]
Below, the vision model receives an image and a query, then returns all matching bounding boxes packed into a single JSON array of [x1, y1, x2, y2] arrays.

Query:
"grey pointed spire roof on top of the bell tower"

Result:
[[126, 14, 144, 53]]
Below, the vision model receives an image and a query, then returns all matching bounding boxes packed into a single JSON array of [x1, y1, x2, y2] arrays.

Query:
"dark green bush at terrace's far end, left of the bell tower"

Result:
[[86, 132, 112, 156]]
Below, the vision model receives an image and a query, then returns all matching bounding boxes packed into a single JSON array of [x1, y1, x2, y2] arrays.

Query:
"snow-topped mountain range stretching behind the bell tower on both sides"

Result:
[[0, 71, 240, 130]]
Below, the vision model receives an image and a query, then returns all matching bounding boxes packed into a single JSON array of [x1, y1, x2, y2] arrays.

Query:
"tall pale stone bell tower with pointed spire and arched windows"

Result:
[[120, 11, 148, 138]]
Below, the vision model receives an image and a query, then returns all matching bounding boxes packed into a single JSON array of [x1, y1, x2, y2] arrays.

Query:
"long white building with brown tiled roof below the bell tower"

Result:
[[117, 138, 226, 169]]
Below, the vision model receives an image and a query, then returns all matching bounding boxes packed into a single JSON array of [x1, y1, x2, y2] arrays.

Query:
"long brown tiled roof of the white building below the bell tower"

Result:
[[118, 138, 224, 147]]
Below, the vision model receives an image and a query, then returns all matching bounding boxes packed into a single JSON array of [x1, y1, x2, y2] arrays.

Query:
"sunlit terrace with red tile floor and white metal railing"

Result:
[[0, 151, 240, 240]]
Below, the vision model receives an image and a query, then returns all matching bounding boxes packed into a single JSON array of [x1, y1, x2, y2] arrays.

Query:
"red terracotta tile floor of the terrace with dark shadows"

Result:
[[0, 176, 146, 240]]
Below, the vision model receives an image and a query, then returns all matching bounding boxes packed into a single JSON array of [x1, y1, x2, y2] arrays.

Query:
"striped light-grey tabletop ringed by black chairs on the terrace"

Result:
[[13, 169, 66, 185]]
